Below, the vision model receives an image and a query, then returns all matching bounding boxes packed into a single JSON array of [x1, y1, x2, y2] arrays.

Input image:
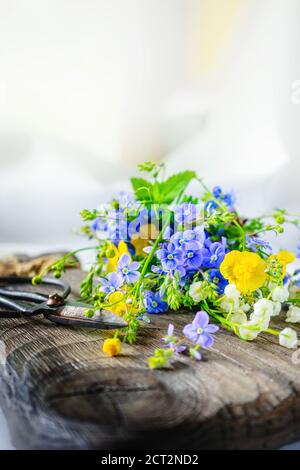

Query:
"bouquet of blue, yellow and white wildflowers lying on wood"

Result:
[[37, 162, 300, 367]]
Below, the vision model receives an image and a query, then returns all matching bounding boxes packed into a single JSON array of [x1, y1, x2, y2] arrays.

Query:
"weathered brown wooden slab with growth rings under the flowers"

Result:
[[0, 270, 300, 450]]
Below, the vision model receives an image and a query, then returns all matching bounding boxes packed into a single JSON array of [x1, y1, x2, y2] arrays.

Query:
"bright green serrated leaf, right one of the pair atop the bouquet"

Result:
[[156, 171, 196, 204]]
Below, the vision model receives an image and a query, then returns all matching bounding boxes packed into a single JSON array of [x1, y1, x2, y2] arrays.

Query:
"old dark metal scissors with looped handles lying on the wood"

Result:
[[0, 276, 127, 330]]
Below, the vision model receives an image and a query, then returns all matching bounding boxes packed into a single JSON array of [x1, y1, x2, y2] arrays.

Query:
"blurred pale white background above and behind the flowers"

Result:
[[0, 0, 300, 448]]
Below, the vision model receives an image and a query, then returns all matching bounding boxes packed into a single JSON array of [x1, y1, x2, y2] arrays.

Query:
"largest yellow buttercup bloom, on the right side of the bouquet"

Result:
[[220, 250, 267, 293]]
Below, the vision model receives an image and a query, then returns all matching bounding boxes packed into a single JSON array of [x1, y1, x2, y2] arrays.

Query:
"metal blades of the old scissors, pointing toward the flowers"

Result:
[[46, 301, 127, 330]]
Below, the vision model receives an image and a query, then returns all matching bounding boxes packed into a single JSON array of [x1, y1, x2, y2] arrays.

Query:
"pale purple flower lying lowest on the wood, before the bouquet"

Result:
[[183, 311, 219, 348]]
